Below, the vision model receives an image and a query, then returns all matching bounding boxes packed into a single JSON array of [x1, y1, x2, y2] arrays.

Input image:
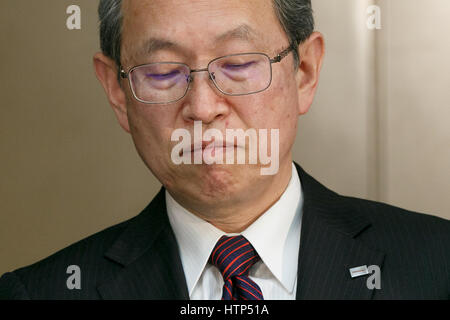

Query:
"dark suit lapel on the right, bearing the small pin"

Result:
[[296, 164, 384, 299]]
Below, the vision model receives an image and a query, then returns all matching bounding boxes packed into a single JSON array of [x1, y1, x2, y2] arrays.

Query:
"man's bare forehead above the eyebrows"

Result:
[[122, 0, 287, 60]]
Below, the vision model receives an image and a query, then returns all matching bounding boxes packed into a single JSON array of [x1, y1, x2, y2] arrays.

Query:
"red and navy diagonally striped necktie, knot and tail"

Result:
[[208, 236, 264, 300]]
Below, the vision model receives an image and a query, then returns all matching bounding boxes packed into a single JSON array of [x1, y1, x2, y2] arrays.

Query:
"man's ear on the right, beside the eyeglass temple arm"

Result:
[[296, 32, 325, 115]]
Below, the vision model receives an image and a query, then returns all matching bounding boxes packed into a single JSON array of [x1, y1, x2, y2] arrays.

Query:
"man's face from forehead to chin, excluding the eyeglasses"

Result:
[[121, 0, 299, 212]]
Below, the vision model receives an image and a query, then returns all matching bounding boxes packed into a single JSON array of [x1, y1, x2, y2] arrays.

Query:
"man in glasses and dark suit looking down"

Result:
[[0, 0, 450, 299]]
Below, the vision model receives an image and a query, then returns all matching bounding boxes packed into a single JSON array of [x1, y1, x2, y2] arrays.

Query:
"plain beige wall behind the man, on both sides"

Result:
[[0, 0, 450, 273]]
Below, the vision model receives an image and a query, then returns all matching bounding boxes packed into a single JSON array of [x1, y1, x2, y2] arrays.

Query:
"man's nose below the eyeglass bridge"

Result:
[[182, 70, 230, 124]]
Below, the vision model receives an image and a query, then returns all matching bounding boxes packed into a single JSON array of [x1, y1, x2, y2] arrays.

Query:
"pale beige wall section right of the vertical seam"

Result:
[[378, 0, 450, 219]]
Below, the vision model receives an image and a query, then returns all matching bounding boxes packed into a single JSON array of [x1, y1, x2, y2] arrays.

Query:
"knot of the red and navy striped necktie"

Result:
[[209, 236, 259, 281]]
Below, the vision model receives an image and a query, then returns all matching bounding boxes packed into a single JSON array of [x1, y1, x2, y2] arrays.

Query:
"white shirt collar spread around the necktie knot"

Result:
[[166, 164, 303, 295]]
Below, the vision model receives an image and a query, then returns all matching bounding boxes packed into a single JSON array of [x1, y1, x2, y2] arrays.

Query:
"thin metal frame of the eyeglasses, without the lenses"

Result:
[[119, 43, 295, 104]]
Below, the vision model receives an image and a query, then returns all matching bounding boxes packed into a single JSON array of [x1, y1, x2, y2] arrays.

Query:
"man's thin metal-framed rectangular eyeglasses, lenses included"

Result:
[[120, 45, 294, 104]]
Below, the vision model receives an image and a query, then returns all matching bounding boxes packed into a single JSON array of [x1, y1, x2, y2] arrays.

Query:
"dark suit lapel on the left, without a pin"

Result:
[[97, 188, 189, 300]]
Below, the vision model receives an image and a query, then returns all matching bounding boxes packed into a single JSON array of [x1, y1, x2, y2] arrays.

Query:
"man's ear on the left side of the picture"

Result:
[[94, 52, 130, 133]]
